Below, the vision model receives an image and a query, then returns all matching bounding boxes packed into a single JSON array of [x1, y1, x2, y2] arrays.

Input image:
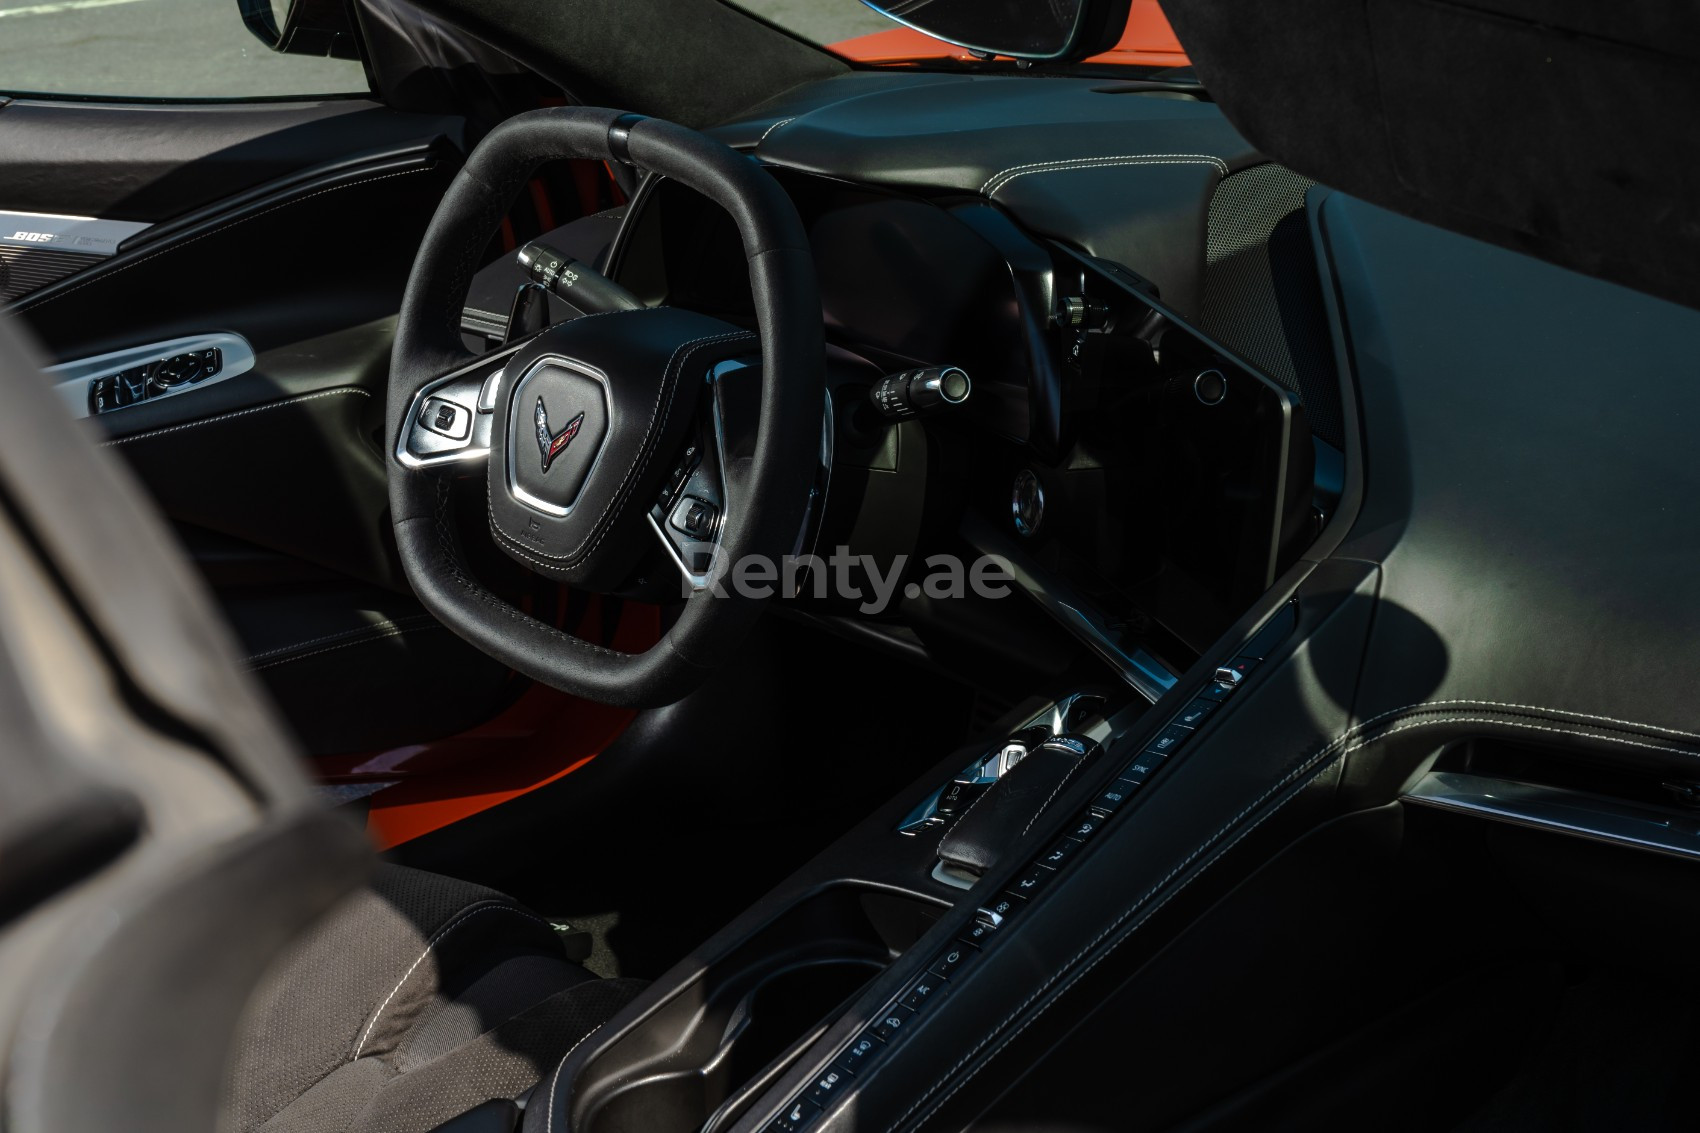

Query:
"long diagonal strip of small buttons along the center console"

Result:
[[765, 602, 1297, 1133]]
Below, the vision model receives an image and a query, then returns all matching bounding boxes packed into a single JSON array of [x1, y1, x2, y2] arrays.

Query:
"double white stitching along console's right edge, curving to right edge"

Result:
[[887, 699, 1700, 1133]]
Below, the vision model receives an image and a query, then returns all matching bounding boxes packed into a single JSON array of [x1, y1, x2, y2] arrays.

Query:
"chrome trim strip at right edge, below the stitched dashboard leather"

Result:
[[1401, 771, 1700, 857]]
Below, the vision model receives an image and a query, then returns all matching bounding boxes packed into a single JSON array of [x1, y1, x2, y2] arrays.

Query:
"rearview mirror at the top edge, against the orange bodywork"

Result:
[[862, 0, 1131, 63]]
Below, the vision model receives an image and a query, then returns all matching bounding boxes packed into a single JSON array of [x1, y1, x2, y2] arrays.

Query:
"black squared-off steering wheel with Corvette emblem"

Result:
[[388, 107, 826, 708]]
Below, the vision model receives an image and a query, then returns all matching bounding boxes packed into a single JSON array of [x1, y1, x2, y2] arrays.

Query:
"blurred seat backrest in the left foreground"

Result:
[[0, 314, 371, 1133]]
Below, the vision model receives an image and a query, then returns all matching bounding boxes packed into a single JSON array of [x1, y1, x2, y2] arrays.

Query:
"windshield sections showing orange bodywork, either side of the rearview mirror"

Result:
[[724, 0, 1187, 66]]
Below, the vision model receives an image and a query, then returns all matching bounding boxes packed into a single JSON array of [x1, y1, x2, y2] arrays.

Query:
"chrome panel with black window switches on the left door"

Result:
[[48, 332, 253, 417]]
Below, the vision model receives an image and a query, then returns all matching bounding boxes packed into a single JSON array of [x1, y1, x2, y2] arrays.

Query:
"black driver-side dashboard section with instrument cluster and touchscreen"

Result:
[[607, 168, 1321, 680]]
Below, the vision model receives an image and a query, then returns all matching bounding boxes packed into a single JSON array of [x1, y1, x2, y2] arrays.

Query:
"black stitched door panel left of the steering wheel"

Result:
[[0, 92, 515, 754]]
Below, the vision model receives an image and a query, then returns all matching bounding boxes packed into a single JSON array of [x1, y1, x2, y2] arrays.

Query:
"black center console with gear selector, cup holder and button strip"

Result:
[[532, 595, 1294, 1133]]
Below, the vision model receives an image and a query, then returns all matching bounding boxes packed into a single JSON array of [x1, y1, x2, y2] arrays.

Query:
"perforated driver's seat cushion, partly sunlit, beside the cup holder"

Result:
[[223, 866, 641, 1133]]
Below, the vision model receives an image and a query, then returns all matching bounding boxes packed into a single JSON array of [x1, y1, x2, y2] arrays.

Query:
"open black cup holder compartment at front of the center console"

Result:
[[571, 885, 945, 1133]]
